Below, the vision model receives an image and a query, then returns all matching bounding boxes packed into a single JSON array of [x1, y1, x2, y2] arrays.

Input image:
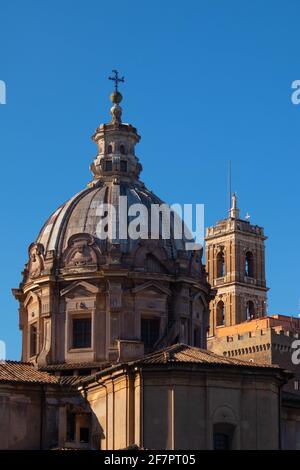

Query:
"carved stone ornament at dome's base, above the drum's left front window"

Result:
[[63, 233, 98, 268]]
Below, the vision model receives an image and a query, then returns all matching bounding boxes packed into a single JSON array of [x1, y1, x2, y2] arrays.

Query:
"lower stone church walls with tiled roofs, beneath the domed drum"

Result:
[[0, 344, 288, 450]]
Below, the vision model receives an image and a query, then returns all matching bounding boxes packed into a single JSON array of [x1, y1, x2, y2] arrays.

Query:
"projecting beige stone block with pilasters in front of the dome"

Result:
[[83, 345, 283, 450]]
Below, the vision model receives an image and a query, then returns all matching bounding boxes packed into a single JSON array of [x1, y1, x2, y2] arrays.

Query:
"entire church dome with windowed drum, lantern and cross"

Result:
[[13, 72, 211, 369]]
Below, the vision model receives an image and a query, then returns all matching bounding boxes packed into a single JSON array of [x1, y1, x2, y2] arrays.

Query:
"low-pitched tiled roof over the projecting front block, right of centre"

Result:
[[134, 344, 279, 369]]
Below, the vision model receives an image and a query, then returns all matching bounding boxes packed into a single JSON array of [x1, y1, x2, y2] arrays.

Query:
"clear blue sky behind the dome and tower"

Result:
[[0, 0, 300, 358]]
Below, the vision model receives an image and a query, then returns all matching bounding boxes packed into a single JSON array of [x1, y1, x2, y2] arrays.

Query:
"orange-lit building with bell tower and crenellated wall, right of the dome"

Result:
[[206, 200, 300, 449]]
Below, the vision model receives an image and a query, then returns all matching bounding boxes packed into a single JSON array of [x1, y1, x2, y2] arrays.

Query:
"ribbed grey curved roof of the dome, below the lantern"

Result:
[[36, 181, 185, 259]]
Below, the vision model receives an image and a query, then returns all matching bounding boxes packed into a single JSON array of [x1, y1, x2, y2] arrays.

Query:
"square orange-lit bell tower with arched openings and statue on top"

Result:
[[205, 193, 268, 336]]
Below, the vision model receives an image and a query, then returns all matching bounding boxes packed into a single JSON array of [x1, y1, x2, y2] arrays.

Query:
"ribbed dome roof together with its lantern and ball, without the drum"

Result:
[[36, 85, 191, 264]]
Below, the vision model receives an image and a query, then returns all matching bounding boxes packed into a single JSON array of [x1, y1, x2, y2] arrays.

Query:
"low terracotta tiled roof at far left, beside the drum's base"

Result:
[[0, 361, 59, 384]]
